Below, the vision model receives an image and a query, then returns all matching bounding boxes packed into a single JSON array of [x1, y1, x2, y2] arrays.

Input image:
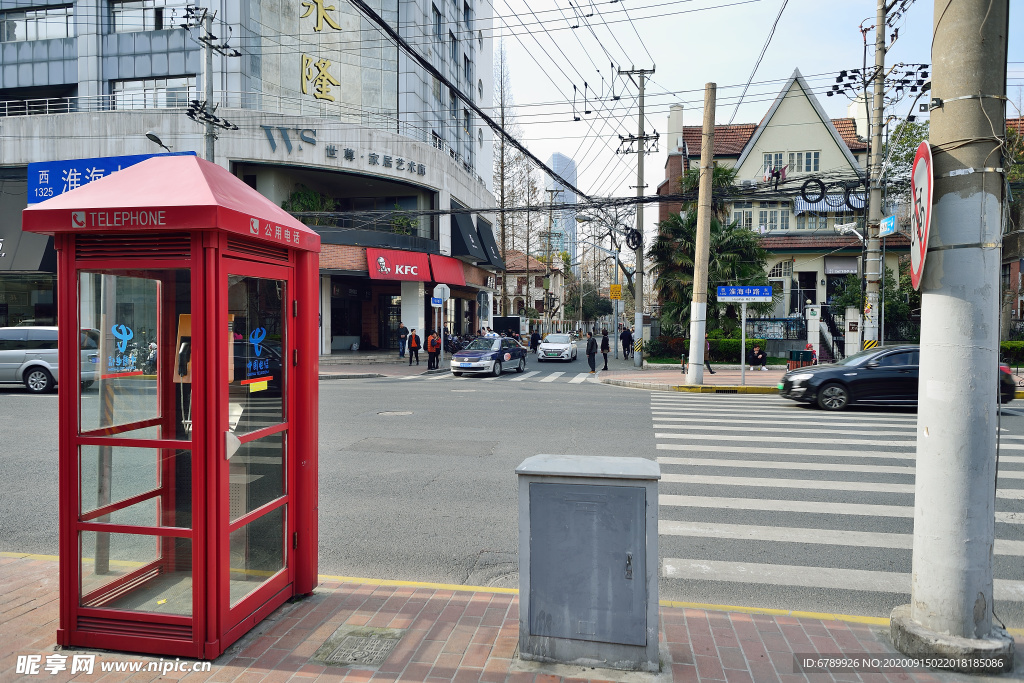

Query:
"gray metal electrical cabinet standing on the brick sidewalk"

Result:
[[516, 455, 662, 671]]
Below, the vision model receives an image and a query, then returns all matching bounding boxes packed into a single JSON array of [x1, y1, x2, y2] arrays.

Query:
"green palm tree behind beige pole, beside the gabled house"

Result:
[[647, 167, 772, 330]]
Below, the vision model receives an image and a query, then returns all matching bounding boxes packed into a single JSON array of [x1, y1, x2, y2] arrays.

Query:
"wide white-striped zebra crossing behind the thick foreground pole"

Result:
[[649, 392, 1024, 628]]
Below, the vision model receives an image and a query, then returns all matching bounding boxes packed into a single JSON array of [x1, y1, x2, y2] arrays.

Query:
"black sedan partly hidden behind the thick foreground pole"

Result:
[[778, 346, 1017, 411]]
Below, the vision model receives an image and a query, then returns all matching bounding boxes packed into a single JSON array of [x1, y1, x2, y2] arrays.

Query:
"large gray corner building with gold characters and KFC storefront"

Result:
[[0, 0, 501, 352]]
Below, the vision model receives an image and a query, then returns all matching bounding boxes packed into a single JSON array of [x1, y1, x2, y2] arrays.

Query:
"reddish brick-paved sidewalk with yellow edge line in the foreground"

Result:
[[0, 553, 1024, 683]]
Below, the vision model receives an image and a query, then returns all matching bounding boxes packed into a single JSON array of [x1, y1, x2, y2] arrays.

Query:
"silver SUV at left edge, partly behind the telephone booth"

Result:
[[0, 327, 99, 393]]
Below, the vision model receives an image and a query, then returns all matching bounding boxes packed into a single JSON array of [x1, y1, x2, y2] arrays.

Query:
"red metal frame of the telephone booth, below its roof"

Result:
[[48, 225, 318, 658]]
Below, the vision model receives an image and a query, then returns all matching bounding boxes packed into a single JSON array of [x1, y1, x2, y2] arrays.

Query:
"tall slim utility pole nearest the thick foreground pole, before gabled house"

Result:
[[863, 0, 895, 341]]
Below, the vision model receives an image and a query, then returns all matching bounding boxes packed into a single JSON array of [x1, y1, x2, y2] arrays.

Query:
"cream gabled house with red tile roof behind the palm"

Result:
[[657, 70, 909, 339]]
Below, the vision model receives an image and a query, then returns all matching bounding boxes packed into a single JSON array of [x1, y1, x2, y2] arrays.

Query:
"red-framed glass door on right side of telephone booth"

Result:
[[216, 258, 295, 641]]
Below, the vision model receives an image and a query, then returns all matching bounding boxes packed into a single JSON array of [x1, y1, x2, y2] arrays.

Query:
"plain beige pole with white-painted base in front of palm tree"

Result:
[[686, 83, 717, 384]]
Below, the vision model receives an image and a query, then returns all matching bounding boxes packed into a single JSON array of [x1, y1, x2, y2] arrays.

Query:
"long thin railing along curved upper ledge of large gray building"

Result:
[[0, 89, 486, 186]]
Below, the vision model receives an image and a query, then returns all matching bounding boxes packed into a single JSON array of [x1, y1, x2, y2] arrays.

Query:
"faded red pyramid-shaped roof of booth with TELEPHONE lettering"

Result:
[[22, 156, 321, 252]]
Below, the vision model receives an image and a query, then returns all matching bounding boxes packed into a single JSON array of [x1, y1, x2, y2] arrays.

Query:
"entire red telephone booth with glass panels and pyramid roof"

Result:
[[23, 157, 319, 658]]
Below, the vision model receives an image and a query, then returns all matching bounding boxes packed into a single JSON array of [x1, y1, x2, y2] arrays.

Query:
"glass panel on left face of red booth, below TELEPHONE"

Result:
[[77, 269, 195, 617]]
